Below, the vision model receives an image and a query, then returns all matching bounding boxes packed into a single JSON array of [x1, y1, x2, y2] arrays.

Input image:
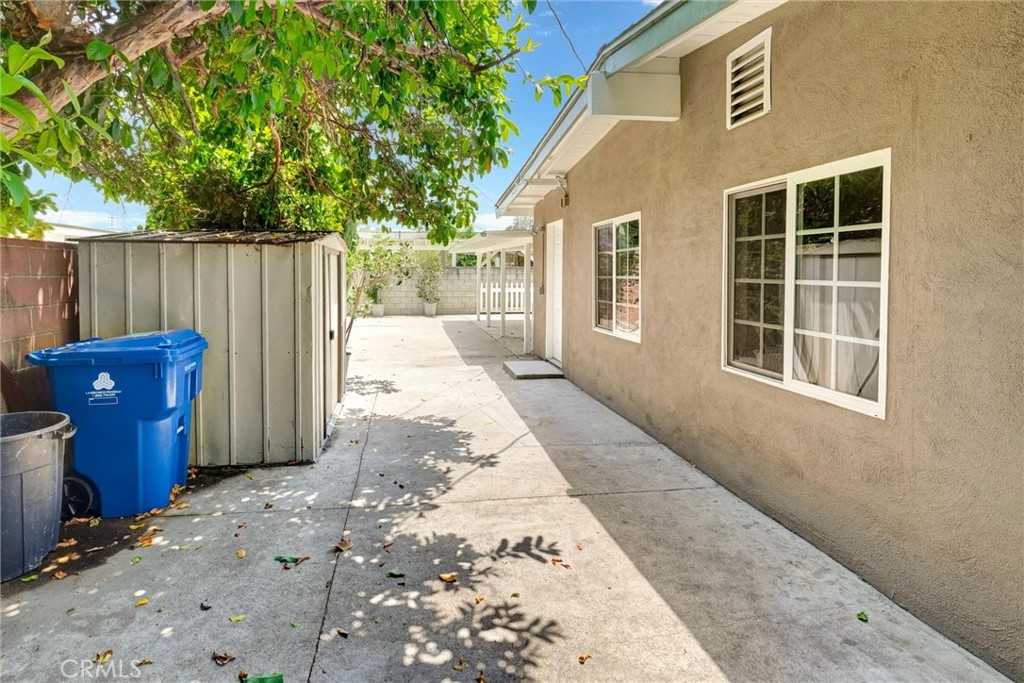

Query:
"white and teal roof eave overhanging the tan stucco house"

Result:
[[496, 0, 786, 216]]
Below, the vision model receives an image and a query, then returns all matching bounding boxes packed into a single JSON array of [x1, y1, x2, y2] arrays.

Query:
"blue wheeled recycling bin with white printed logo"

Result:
[[27, 330, 208, 517]]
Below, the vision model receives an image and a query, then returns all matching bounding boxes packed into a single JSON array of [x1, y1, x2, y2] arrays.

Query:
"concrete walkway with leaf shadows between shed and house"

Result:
[[0, 317, 1006, 683]]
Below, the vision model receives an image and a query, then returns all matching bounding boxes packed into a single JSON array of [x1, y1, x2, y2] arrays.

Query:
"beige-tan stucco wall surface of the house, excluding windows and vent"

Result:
[[535, 2, 1024, 677]]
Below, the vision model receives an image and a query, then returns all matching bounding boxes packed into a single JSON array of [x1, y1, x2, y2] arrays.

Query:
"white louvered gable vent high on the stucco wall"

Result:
[[725, 28, 771, 129]]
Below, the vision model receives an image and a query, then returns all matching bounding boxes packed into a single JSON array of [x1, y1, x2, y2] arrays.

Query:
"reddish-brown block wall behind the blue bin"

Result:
[[0, 238, 79, 411]]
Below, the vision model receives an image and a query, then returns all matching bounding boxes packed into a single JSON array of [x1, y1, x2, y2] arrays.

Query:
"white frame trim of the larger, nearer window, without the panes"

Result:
[[720, 147, 892, 420]]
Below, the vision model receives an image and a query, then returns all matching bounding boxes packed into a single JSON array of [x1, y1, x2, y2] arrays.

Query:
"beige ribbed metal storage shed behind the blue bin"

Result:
[[79, 230, 345, 466]]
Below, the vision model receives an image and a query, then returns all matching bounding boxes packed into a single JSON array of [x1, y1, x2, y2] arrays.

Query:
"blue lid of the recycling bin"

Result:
[[26, 330, 209, 367]]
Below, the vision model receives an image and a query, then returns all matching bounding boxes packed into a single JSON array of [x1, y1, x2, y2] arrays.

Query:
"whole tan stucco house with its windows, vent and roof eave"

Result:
[[498, 0, 1024, 678]]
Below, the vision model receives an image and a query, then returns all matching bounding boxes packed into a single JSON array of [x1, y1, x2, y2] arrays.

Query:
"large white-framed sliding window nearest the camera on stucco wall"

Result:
[[722, 150, 891, 418]]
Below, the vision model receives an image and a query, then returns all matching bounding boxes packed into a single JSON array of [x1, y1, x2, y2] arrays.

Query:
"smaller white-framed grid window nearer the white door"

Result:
[[593, 212, 640, 342]]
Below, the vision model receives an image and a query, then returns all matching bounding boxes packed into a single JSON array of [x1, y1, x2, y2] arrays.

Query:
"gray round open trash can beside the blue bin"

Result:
[[0, 412, 75, 581]]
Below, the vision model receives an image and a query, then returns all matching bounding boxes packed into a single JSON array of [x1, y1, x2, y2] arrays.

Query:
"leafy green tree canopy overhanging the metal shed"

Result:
[[0, 0, 583, 242]]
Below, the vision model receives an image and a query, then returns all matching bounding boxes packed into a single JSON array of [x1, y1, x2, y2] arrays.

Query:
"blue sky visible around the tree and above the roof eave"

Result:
[[30, 0, 659, 230]]
